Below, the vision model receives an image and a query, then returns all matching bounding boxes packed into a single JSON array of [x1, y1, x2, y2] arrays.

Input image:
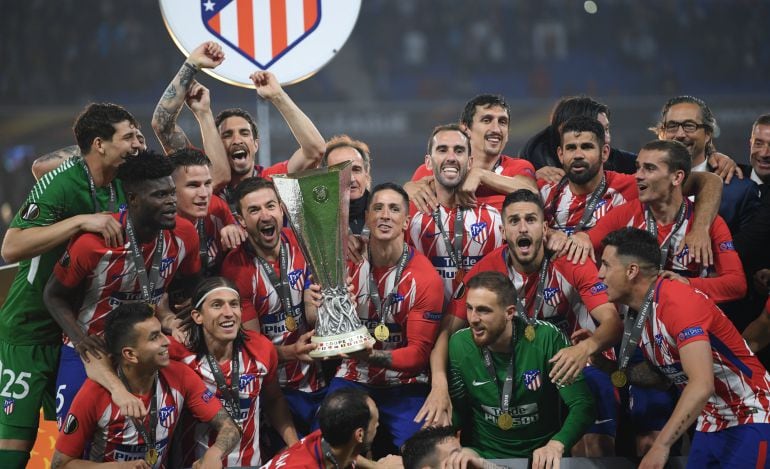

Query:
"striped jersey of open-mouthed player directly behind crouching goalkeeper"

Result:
[[447, 245, 609, 337]]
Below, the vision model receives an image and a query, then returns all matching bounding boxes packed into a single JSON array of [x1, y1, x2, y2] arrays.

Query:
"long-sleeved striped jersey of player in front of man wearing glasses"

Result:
[[587, 199, 746, 303]]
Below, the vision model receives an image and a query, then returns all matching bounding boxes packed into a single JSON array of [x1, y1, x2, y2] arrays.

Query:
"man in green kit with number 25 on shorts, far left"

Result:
[[0, 104, 141, 468]]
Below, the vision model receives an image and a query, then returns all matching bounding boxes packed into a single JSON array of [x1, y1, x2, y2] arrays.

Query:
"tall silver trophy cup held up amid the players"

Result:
[[273, 162, 373, 358]]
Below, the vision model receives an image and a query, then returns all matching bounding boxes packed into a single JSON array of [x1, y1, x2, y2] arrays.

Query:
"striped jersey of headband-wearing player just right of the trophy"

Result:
[[337, 247, 444, 386]]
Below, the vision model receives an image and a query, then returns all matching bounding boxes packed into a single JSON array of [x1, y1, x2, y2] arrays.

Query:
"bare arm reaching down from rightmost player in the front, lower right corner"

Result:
[[639, 340, 714, 468]]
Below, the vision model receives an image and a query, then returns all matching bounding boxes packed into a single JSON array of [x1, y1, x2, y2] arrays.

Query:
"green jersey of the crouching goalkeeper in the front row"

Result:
[[449, 317, 595, 458]]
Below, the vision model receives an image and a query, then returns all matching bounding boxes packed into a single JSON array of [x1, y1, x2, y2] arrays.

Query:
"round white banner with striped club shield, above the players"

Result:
[[160, 0, 361, 88]]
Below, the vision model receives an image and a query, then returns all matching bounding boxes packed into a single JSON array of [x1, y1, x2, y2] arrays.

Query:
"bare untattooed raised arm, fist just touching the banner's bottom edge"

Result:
[[249, 72, 326, 173]]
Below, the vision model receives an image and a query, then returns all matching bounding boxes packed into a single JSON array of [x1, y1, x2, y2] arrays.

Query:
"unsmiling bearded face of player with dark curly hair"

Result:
[[557, 132, 609, 185]]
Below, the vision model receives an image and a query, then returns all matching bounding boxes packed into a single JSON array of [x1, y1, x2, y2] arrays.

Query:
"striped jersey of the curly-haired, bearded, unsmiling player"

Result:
[[537, 171, 639, 233]]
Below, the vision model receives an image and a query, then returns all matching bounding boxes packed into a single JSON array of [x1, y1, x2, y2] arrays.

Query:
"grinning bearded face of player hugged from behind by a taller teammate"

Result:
[[425, 130, 470, 189]]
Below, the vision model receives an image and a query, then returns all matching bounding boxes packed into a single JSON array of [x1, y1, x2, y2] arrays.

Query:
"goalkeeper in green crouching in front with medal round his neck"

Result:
[[449, 271, 595, 468]]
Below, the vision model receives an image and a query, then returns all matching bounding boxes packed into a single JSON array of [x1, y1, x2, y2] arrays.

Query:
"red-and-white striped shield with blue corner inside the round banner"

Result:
[[200, 0, 321, 70]]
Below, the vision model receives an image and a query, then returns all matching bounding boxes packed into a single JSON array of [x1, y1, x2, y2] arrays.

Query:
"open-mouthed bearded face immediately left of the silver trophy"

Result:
[[238, 188, 283, 254]]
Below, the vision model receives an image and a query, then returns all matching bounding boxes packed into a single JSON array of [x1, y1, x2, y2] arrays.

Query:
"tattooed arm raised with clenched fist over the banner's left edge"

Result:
[[152, 42, 224, 154]]
